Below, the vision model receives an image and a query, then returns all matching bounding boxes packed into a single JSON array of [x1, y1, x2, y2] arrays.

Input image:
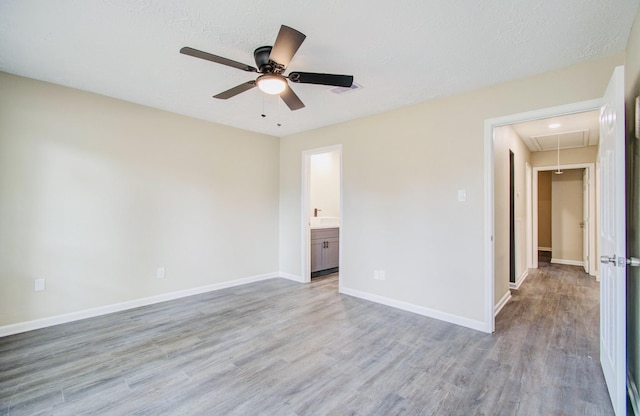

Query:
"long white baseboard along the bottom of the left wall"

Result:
[[0, 272, 282, 337]]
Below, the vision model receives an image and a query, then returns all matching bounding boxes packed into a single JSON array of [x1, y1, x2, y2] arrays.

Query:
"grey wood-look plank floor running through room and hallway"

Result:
[[0, 258, 613, 416]]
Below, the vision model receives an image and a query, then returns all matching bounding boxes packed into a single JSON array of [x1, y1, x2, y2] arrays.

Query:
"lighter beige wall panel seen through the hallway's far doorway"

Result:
[[551, 169, 584, 262]]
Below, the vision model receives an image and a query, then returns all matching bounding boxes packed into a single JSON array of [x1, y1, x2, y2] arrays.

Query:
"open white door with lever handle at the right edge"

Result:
[[598, 67, 627, 415]]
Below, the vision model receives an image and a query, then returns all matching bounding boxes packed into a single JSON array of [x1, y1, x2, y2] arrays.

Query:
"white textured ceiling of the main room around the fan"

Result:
[[0, 0, 638, 136]]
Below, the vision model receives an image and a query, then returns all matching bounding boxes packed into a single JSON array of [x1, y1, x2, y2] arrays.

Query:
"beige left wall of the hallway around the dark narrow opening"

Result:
[[493, 126, 531, 303]]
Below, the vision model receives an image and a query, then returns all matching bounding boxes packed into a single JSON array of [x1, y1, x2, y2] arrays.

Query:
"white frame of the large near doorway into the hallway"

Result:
[[484, 98, 602, 332]]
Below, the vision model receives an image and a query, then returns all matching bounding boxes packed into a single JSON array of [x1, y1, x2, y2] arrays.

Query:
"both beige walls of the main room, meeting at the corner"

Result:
[[0, 49, 622, 332]]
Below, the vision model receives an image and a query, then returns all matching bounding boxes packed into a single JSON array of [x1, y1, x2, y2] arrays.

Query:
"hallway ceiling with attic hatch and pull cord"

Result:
[[511, 110, 600, 152]]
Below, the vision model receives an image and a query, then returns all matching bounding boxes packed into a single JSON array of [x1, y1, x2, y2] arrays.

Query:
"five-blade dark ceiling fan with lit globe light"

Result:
[[180, 25, 353, 110]]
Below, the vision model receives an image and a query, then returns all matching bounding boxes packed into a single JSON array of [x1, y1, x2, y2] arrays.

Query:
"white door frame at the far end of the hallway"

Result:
[[531, 163, 598, 276]]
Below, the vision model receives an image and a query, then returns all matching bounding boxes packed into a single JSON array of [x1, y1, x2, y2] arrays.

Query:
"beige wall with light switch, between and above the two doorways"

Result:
[[280, 56, 622, 324]]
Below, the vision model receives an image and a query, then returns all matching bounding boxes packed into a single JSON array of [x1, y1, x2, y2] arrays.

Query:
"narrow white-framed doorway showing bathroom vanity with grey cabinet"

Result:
[[301, 145, 342, 283]]
